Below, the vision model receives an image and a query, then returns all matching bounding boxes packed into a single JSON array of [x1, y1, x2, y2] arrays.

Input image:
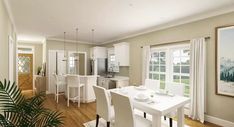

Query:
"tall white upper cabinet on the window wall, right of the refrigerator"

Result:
[[114, 42, 129, 66]]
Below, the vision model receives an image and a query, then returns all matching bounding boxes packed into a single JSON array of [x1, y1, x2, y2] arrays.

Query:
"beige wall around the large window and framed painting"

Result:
[[102, 13, 234, 122]]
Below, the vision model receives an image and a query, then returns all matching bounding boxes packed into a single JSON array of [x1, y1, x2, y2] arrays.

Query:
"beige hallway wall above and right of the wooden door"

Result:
[[18, 42, 43, 75]]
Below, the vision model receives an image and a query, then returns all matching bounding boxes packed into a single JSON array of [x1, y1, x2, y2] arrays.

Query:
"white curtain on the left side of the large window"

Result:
[[142, 46, 150, 85]]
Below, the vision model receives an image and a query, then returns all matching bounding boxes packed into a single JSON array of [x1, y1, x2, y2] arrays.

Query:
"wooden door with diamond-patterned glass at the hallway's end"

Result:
[[18, 53, 33, 90]]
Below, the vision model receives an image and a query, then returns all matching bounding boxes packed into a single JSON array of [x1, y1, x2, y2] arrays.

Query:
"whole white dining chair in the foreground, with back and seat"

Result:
[[111, 92, 152, 127]]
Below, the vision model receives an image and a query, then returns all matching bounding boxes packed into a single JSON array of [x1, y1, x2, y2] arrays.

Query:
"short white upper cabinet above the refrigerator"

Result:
[[90, 46, 107, 59]]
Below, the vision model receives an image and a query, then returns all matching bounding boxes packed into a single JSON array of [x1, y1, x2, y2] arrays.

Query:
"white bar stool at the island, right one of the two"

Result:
[[67, 75, 85, 107]]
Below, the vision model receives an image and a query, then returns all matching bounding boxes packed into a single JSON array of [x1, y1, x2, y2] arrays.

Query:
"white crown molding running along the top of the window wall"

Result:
[[99, 5, 234, 45]]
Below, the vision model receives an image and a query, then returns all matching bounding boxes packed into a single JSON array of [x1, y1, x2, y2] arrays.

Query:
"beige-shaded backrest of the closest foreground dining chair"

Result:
[[111, 92, 135, 127]]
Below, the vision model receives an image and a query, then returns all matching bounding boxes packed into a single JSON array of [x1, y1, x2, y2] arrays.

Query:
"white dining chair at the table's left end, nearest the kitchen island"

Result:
[[93, 86, 115, 127]]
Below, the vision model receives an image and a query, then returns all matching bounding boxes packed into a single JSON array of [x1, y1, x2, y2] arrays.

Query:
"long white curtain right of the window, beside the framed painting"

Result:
[[189, 38, 206, 123]]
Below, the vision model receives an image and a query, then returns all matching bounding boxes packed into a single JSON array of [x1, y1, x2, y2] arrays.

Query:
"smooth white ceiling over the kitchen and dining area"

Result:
[[7, 0, 234, 43]]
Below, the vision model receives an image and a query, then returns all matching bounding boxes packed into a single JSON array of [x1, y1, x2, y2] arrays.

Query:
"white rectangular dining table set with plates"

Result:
[[109, 86, 190, 127]]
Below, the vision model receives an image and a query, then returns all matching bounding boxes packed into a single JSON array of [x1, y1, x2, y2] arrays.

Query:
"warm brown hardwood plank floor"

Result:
[[24, 92, 220, 127]]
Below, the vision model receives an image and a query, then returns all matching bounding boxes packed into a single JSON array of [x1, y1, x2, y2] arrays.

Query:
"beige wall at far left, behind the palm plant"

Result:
[[0, 0, 16, 81]]
